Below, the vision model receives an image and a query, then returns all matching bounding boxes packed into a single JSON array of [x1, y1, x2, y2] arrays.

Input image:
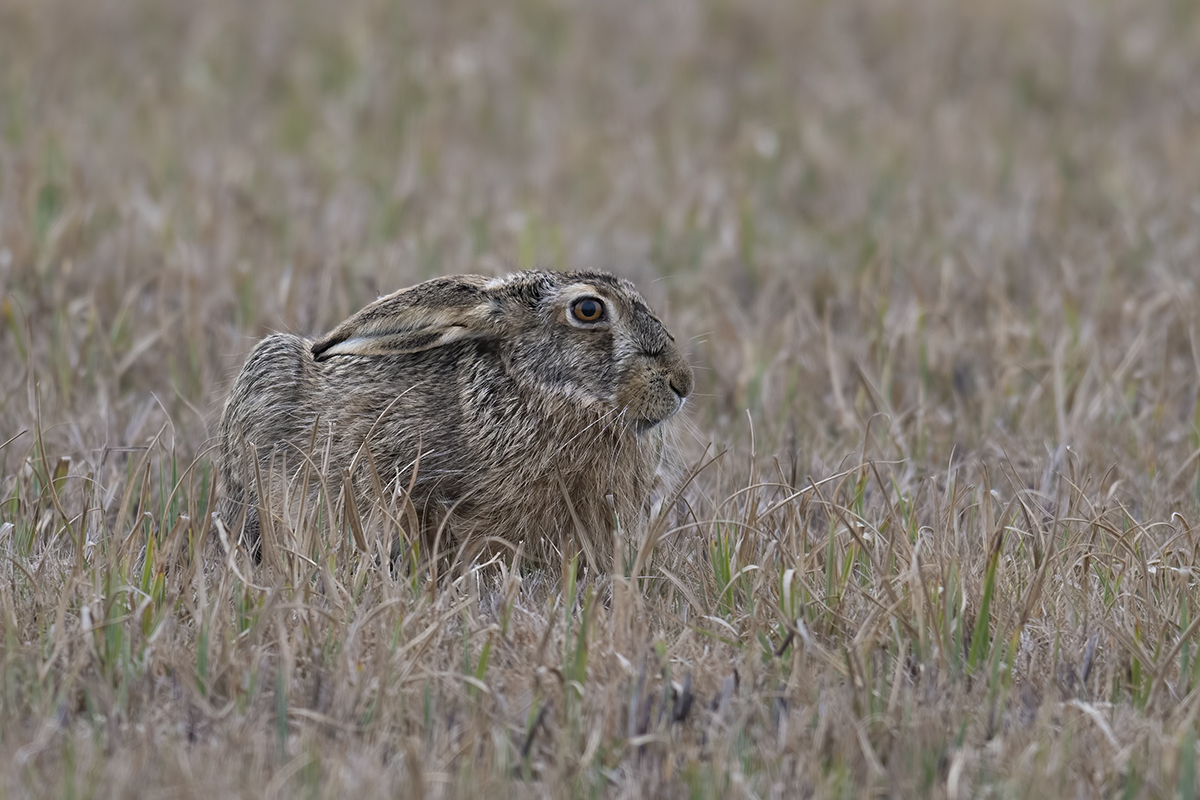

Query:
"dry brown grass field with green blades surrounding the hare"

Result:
[[0, 0, 1200, 799]]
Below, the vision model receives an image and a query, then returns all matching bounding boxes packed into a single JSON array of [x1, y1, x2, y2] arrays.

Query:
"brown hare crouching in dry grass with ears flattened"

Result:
[[217, 271, 692, 569]]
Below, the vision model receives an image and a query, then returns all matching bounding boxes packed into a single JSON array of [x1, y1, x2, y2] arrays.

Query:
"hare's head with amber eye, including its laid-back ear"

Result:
[[313, 271, 692, 433]]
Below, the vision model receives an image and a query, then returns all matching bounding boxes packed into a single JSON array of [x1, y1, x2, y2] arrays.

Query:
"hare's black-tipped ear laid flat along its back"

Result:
[[312, 276, 505, 361]]
